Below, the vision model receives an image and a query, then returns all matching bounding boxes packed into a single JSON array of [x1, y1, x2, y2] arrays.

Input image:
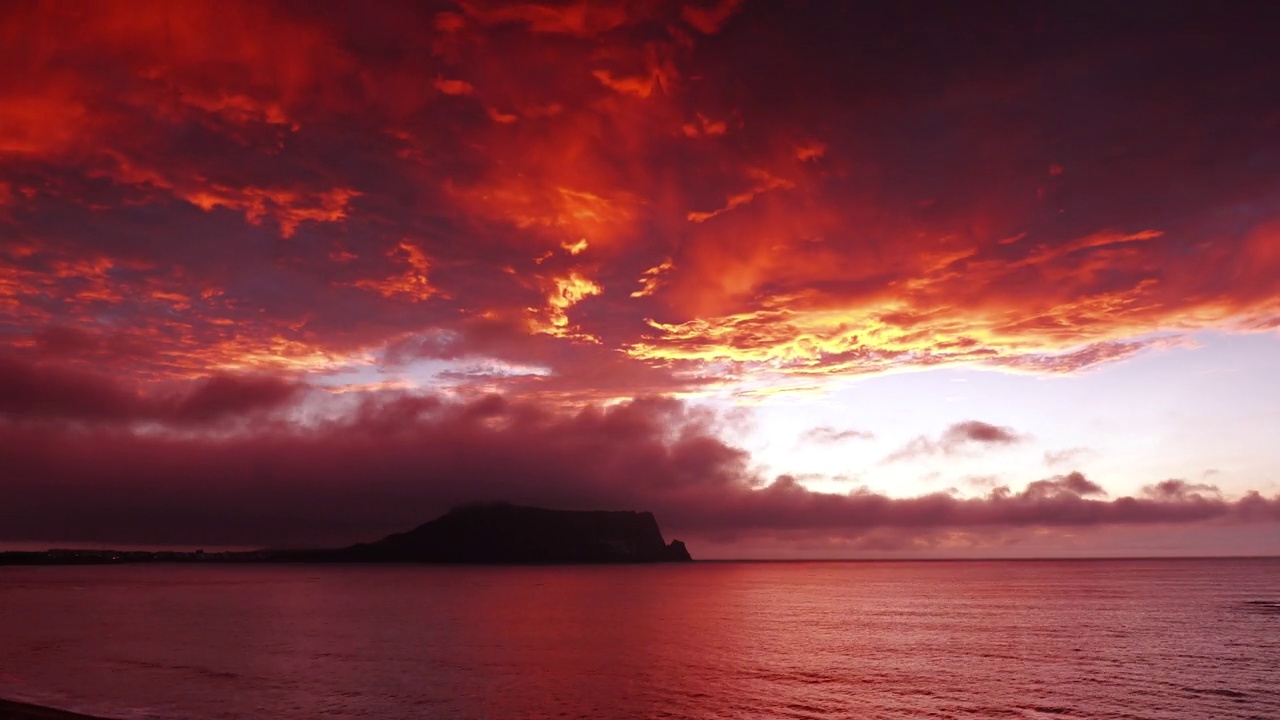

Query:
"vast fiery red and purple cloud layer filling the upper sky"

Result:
[[0, 1, 1280, 387]]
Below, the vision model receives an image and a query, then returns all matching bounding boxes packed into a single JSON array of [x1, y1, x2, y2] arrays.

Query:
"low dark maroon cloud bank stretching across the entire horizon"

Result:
[[0, 389, 1280, 544]]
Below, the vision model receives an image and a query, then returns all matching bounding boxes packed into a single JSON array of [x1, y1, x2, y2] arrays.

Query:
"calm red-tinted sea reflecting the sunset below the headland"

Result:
[[0, 560, 1280, 720]]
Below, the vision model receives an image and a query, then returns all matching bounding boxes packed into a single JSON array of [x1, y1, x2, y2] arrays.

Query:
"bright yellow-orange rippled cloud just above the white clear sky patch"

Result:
[[627, 213, 1277, 375]]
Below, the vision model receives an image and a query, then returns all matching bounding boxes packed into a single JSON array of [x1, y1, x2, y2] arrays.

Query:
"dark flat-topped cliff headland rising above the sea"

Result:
[[342, 505, 691, 564]]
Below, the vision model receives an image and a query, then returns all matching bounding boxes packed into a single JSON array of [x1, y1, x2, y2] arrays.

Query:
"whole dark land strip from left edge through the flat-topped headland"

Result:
[[0, 503, 692, 565]]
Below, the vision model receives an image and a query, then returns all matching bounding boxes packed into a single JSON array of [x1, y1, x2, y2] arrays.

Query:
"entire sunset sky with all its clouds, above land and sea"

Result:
[[0, 0, 1280, 557]]
